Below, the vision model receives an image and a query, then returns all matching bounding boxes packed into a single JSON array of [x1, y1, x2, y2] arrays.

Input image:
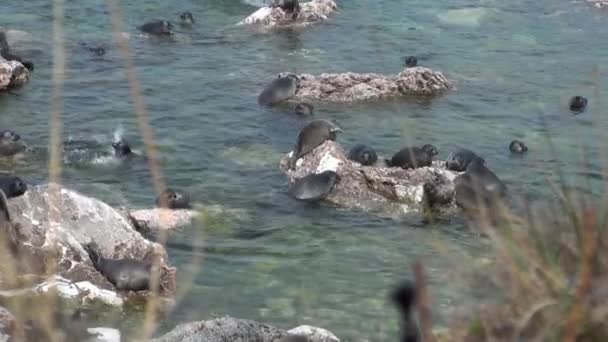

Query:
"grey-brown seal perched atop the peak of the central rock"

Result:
[[288, 119, 342, 170]]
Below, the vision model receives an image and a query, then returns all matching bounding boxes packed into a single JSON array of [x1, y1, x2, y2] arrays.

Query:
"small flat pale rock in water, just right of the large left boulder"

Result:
[[127, 208, 198, 235]]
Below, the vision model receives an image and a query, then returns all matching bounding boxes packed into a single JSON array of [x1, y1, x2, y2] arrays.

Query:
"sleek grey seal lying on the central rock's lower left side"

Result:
[[287, 171, 339, 202]]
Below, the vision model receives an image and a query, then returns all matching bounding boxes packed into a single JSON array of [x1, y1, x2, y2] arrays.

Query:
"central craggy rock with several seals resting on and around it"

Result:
[[279, 141, 459, 213]]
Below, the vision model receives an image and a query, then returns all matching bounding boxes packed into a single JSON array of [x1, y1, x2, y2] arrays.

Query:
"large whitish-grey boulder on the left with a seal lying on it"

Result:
[[0, 185, 175, 305]]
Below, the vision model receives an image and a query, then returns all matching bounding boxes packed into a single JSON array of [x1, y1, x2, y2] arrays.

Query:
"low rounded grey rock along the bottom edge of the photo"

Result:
[[153, 317, 340, 342]]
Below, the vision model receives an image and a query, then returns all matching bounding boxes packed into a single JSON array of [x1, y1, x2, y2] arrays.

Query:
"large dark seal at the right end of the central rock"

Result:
[[454, 159, 507, 212]]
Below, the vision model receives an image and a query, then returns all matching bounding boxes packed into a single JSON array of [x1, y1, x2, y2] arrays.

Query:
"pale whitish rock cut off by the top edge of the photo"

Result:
[[237, 0, 338, 28]]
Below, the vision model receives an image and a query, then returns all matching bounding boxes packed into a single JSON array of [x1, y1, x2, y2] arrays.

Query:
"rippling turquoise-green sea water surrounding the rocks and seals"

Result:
[[0, 0, 608, 341]]
